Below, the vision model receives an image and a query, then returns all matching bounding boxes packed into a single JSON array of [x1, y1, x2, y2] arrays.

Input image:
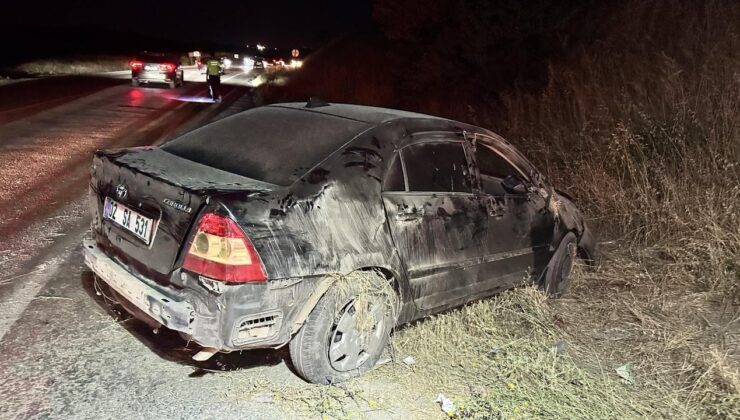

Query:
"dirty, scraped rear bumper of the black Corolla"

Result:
[[83, 238, 317, 352]]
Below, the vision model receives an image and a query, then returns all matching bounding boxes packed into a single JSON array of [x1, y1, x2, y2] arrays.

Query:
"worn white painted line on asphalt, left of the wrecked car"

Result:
[[0, 251, 71, 341]]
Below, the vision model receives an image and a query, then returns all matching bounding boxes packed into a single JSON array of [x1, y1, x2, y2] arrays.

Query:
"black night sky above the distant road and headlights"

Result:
[[0, 0, 372, 60]]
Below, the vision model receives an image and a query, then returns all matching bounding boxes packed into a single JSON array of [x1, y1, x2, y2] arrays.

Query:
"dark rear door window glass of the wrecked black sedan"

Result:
[[401, 142, 472, 193]]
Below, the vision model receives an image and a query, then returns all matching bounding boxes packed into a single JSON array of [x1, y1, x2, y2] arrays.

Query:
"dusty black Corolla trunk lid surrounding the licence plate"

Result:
[[90, 147, 275, 282]]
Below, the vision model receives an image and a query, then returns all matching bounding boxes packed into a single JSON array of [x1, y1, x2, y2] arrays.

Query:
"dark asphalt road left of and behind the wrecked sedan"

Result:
[[0, 68, 310, 418]]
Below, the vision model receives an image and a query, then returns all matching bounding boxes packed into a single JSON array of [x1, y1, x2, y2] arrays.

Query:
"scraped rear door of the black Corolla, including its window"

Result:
[[383, 140, 488, 311]]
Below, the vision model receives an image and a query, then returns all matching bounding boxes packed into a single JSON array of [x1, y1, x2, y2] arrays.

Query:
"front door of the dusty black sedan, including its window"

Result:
[[472, 143, 554, 290]]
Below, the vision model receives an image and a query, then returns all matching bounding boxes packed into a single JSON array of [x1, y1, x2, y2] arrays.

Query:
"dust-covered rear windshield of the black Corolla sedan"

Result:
[[162, 107, 368, 185]]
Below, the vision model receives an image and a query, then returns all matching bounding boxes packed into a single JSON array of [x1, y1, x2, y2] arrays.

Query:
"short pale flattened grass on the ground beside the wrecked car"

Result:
[[239, 266, 740, 419]]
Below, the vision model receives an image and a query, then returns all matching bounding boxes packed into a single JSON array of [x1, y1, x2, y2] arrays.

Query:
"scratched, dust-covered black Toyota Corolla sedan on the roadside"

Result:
[[84, 101, 594, 383]]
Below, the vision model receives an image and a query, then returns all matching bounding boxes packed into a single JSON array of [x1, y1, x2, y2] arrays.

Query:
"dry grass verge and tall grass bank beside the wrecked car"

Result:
[[250, 0, 740, 418]]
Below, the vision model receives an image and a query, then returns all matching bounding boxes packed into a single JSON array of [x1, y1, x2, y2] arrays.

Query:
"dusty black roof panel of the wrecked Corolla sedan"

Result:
[[268, 102, 446, 125]]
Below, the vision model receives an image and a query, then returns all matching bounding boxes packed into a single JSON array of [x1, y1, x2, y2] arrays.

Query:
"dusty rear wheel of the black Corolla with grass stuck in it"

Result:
[[290, 272, 398, 384]]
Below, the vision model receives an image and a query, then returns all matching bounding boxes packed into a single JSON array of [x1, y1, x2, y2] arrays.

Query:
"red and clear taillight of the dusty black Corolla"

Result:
[[182, 213, 267, 283]]
